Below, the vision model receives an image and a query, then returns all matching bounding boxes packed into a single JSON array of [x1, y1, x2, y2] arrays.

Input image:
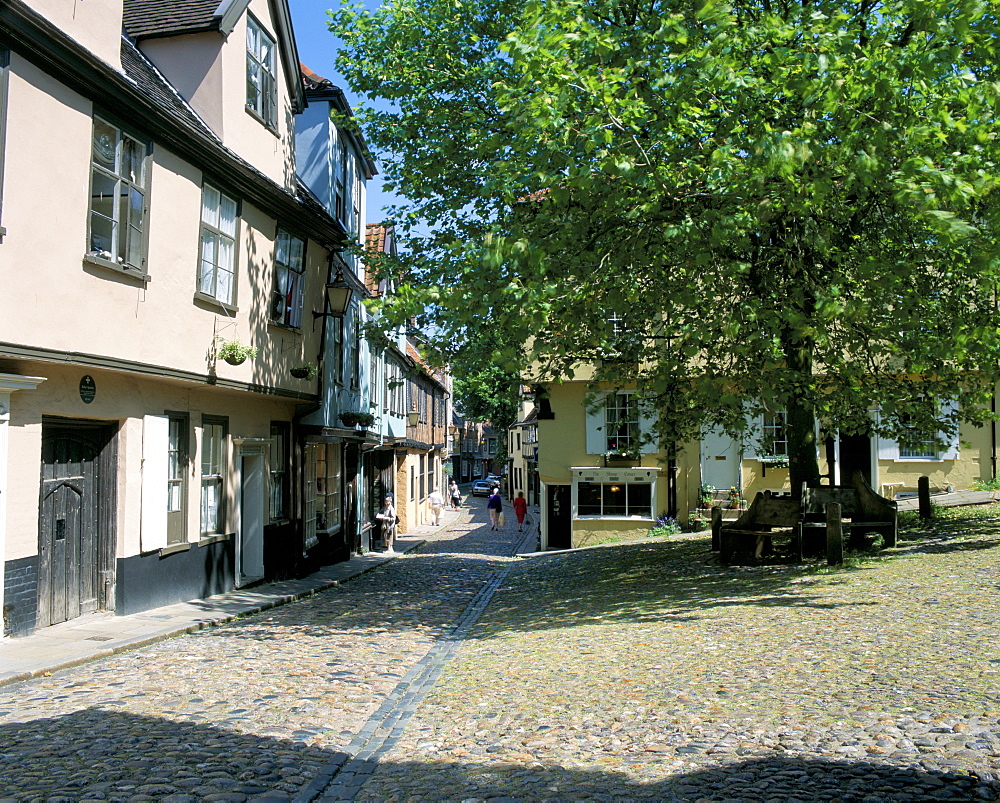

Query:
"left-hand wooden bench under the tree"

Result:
[[712, 491, 802, 564]]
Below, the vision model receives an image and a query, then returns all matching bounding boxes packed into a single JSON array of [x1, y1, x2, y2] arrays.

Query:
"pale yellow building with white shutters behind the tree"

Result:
[[533, 380, 996, 549]]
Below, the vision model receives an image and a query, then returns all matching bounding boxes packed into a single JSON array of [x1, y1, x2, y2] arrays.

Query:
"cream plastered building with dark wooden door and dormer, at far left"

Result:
[[0, 0, 360, 635]]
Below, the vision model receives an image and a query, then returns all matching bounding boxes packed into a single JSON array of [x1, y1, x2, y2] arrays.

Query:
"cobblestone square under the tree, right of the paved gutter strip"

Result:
[[358, 520, 1000, 802]]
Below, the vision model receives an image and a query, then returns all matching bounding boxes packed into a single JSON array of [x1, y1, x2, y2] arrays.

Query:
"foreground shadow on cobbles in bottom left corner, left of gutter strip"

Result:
[[0, 708, 333, 801]]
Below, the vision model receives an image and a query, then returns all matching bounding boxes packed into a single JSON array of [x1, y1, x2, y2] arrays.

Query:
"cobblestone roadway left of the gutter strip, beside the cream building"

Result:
[[0, 503, 523, 801]]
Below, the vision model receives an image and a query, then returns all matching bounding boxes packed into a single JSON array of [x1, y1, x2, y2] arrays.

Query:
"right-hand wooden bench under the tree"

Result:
[[802, 472, 899, 552]]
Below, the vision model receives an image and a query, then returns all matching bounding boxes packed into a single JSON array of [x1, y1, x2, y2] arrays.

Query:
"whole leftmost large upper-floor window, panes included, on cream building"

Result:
[[87, 117, 150, 271]]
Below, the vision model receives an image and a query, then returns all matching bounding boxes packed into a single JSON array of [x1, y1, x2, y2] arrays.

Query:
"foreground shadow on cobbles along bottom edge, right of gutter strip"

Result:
[[357, 755, 1000, 803]]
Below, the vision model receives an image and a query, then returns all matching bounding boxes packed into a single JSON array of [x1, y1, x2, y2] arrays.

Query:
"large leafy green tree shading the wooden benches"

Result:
[[332, 0, 1000, 488]]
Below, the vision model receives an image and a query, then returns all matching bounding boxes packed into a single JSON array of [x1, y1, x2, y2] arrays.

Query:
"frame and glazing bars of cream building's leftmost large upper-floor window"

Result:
[[84, 111, 153, 281]]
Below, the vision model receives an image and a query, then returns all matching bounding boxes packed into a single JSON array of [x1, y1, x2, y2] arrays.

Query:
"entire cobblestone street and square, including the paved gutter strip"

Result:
[[0, 502, 1000, 801]]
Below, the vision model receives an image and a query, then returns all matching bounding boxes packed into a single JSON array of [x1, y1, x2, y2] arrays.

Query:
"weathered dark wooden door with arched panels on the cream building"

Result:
[[37, 420, 114, 627]]
